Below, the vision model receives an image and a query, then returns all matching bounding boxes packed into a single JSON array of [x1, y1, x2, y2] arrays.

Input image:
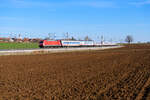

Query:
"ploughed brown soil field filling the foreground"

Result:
[[0, 44, 150, 100]]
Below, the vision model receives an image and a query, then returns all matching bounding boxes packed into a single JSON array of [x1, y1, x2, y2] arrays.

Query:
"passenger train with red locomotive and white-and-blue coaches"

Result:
[[39, 40, 114, 48]]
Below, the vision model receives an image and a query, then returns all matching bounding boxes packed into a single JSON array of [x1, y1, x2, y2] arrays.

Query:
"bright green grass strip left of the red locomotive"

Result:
[[0, 43, 39, 49]]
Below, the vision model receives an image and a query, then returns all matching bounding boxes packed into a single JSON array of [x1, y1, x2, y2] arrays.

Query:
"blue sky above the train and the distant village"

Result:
[[0, 0, 150, 42]]
